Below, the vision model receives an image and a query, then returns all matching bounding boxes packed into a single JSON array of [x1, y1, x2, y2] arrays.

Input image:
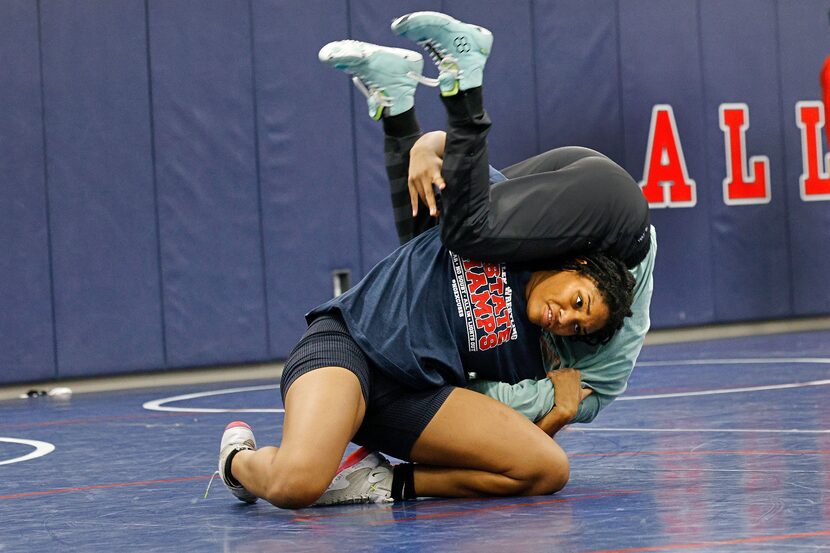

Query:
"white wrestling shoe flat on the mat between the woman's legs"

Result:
[[312, 447, 393, 507]]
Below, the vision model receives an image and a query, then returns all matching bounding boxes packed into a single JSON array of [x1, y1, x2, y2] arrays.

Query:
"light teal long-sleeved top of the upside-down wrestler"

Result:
[[469, 227, 657, 422]]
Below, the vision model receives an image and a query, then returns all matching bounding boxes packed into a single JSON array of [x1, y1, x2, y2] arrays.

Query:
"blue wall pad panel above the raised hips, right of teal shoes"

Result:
[[536, 0, 625, 163]]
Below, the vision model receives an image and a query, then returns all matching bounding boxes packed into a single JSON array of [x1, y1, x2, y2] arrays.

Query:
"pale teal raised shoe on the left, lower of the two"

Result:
[[319, 40, 424, 120]]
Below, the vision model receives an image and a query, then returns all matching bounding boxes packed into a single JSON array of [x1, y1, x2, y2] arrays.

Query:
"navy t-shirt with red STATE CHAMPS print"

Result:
[[306, 227, 544, 388]]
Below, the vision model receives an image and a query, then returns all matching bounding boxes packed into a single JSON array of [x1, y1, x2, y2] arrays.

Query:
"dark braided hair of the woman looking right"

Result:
[[557, 252, 635, 345]]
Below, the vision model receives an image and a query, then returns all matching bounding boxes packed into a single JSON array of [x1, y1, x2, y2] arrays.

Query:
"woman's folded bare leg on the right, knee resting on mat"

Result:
[[412, 388, 569, 497]]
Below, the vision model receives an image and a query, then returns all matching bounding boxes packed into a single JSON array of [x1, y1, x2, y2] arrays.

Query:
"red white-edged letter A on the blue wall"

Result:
[[640, 104, 697, 207]]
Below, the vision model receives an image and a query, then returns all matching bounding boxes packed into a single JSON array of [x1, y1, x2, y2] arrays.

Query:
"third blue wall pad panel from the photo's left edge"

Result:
[[149, 0, 268, 366]]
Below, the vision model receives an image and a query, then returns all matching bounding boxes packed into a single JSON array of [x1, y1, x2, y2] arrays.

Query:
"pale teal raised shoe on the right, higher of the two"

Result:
[[392, 12, 493, 96]]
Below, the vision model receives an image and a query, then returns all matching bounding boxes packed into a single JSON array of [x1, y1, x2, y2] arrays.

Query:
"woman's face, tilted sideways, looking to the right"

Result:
[[525, 271, 608, 336]]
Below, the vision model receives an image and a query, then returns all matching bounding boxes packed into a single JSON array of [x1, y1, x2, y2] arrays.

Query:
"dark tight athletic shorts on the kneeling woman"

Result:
[[280, 313, 453, 461]]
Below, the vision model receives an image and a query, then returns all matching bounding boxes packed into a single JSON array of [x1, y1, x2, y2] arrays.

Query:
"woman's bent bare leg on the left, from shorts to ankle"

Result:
[[231, 367, 366, 509]]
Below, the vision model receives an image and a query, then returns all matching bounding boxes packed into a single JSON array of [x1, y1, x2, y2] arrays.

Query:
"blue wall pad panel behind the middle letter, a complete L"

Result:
[[700, 0, 792, 321]]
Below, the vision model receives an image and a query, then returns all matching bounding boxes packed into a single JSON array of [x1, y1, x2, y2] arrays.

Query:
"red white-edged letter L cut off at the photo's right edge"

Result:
[[795, 102, 830, 202]]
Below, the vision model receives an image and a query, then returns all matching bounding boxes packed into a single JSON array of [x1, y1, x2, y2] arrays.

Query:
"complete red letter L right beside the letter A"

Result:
[[718, 104, 770, 205]]
